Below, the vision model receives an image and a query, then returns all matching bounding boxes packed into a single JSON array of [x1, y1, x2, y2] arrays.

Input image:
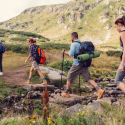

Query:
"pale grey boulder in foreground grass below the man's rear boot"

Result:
[[83, 101, 105, 113]]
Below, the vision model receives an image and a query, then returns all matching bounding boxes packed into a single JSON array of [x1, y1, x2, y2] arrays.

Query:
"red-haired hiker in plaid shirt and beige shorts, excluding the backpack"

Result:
[[25, 38, 47, 84]]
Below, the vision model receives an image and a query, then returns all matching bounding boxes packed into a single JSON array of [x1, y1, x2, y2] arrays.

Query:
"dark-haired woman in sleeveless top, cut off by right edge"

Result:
[[115, 16, 125, 93]]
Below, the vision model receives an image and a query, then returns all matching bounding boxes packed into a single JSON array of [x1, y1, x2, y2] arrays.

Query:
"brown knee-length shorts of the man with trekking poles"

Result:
[[67, 65, 92, 83]]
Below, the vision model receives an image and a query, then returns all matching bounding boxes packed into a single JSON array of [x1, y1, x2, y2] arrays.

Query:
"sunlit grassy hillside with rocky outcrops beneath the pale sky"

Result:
[[0, 0, 125, 46]]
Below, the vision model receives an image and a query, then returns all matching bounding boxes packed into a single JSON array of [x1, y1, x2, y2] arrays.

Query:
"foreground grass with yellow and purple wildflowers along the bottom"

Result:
[[0, 103, 125, 125]]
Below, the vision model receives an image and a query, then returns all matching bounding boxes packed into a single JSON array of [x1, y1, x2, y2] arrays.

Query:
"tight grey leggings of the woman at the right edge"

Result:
[[115, 66, 125, 86]]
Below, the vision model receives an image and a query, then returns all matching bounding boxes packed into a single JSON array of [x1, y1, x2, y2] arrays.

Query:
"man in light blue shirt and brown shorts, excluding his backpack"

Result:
[[61, 32, 104, 99]]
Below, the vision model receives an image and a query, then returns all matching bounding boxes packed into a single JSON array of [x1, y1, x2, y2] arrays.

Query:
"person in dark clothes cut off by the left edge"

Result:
[[0, 43, 5, 76]]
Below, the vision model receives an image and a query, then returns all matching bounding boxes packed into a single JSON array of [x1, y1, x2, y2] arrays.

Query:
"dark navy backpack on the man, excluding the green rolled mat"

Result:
[[74, 41, 95, 67]]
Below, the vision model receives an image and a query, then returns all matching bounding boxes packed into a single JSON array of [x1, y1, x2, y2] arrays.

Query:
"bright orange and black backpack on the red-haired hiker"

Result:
[[36, 45, 46, 64]]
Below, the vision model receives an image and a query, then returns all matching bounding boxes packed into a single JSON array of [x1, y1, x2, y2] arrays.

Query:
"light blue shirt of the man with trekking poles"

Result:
[[68, 40, 81, 66]]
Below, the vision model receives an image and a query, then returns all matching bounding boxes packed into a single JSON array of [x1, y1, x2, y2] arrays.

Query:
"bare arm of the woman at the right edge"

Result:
[[119, 32, 125, 72]]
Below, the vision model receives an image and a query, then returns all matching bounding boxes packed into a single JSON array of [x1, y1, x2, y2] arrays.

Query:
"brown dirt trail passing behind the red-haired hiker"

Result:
[[0, 51, 62, 85]]
